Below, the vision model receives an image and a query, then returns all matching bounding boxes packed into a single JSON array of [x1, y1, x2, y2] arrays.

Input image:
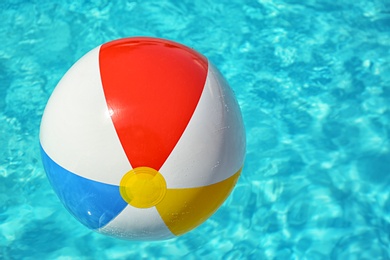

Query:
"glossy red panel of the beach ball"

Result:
[[99, 38, 208, 170]]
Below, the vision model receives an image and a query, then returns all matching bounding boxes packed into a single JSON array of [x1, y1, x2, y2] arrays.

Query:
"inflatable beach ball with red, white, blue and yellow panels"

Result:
[[40, 37, 245, 240]]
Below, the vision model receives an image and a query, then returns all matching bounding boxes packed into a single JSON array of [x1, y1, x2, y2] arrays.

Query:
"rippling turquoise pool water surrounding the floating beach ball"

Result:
[[0, 0, 390, 259]]
